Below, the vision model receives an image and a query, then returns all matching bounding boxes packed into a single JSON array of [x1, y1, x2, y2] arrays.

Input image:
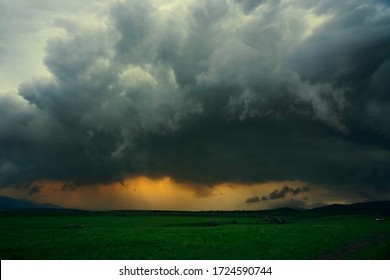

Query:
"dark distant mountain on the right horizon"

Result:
[[309, 201, 390, 215]]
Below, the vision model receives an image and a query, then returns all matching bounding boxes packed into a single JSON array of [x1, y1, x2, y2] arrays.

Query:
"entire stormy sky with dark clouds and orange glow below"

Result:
[[0, 0, 390, 210]]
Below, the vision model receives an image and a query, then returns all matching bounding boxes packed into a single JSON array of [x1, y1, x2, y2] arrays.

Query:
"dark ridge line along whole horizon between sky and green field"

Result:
[[0, 196, 390, 218]]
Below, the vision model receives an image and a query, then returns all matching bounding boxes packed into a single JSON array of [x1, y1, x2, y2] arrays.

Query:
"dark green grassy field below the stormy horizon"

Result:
[[0, 212, 390, 260]]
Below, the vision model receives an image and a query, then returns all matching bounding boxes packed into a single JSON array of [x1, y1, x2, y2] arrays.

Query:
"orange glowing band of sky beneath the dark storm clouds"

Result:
[[0, 176, 350, 211]]
